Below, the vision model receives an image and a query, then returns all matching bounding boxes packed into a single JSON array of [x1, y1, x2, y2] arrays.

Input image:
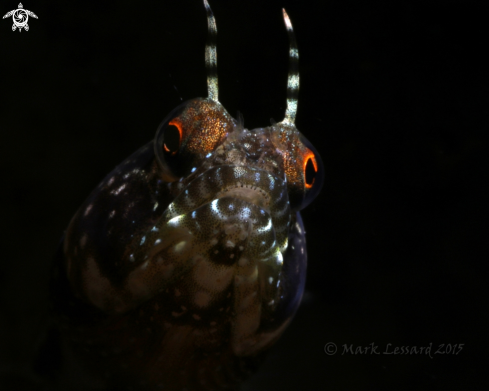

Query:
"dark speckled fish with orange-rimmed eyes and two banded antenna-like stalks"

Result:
[[52, 0, 323, 391]]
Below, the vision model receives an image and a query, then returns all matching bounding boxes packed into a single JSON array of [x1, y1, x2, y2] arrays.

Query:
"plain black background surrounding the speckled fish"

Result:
[[0, 0, 489, 391]]
